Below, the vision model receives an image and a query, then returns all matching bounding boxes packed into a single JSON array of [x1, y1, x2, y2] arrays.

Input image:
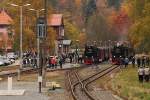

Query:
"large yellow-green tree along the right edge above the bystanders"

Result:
[[128, 0, 150, 52]]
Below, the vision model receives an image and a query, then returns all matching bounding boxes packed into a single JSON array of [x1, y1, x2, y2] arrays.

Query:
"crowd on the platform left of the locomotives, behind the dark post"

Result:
[[22, 51, 83, 69]]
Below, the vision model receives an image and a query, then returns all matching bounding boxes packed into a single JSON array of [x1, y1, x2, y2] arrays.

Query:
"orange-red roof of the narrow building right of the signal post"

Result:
[[48, 14, 63, 26]]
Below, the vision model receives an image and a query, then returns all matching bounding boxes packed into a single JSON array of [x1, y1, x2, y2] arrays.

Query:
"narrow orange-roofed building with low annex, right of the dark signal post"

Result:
[[48, 14, 71, 55]]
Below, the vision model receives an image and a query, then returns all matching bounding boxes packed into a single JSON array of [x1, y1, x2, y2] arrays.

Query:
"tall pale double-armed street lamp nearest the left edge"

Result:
[[10, 3, 31, 80]]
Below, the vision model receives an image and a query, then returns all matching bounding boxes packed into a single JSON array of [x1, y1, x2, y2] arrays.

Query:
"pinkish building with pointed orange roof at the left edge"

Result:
[[0, 10, 14, 52]]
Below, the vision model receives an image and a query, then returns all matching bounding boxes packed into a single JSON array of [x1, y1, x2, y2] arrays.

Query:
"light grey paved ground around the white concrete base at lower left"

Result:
[[0, 82, 49, 100]]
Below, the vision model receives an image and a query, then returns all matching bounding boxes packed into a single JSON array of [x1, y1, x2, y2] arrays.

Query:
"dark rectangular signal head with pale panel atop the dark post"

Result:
[[37, 17, 46, 38]]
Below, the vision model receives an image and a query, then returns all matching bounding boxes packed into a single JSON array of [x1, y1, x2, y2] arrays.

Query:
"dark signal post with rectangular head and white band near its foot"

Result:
[[37, 17, 46, 93]]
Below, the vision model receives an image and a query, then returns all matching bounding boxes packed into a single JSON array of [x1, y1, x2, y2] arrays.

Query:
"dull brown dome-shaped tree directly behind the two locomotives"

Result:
[[86, 14, 110, 41]]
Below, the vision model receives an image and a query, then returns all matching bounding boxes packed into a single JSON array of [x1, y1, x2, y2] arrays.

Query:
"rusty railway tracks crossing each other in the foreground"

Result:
[[67, 65, 119, 100]]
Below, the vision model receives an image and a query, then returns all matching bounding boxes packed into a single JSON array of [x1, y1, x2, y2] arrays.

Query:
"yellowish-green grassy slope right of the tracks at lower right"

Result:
[[109, 67, 150, 100]]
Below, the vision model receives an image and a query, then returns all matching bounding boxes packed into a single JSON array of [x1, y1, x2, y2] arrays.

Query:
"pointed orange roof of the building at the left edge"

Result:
[[0, 10, 13, 25]]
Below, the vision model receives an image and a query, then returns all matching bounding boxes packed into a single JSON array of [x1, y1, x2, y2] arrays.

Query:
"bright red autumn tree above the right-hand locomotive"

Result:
[[109, 6, 131, 41]]
